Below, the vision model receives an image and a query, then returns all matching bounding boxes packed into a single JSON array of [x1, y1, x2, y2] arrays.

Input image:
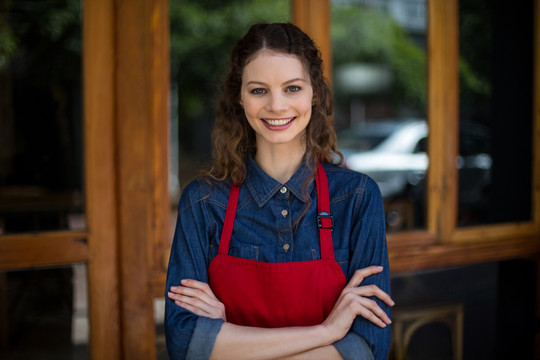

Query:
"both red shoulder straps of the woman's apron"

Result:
[[218, 164, 334, 260]]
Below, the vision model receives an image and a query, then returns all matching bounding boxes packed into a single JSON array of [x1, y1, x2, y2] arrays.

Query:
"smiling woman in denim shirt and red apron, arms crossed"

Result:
[[165, 24, 393, 359]]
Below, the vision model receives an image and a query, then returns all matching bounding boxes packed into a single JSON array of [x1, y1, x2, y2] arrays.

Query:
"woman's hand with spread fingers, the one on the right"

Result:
[[323, 266, 394, 340]]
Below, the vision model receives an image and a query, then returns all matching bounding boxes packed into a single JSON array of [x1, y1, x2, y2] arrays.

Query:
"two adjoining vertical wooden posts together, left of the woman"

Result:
[[83, 0, 169, 360]]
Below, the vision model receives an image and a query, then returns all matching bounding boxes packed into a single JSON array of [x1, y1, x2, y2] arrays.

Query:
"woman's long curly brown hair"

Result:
[[206, 23, 343, 184]]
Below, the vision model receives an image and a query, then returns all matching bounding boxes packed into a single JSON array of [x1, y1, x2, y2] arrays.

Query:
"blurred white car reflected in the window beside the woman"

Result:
[[338, 120, 428, 198]]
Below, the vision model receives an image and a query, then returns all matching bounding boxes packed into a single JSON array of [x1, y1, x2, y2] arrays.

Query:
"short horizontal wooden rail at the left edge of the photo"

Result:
[[0, 231, 88, 270]]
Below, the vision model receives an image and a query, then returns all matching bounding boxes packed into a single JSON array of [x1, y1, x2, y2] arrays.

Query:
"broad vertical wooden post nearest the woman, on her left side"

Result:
[[115, 0, 169, 359]]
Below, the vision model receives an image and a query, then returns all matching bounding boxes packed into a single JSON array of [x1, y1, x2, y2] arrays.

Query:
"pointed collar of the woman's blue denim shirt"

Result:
[[244, 157, 313, 207]]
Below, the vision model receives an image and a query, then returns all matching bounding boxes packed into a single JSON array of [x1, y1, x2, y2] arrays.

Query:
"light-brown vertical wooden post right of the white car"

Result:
[[427, 0, 459, 242]]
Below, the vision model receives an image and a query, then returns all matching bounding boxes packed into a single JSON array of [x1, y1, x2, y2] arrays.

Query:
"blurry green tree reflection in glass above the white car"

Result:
[[332, 6, 426, 118]]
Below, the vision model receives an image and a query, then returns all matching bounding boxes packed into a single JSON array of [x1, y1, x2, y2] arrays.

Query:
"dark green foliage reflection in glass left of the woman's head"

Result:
[[170, 0, 290, 155]]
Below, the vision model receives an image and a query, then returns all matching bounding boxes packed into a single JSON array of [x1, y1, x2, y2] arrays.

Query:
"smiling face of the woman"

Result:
[[240, 50, 313, 151]]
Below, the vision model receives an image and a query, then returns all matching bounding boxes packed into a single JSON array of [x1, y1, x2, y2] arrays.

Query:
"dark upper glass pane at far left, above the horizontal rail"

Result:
[[0, 0, 84, 234]]
